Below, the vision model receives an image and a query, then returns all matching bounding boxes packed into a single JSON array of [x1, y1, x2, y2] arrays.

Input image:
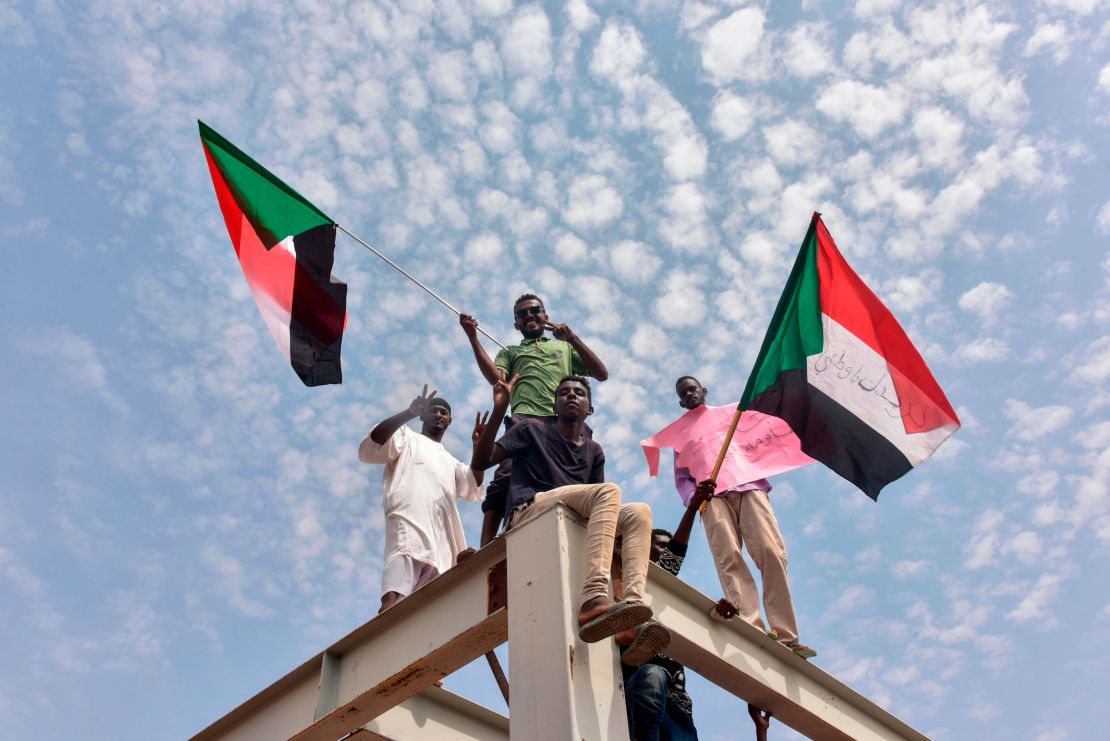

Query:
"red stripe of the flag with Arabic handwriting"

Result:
[[814, 214, 959, 433]]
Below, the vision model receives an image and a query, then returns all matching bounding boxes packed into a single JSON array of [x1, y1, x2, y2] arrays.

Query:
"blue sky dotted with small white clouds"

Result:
[[0, 0, 1110, 741]]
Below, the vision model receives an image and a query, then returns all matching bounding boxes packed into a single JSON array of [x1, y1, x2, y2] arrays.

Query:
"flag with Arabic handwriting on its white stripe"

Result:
[[740, 213, 960, 499]]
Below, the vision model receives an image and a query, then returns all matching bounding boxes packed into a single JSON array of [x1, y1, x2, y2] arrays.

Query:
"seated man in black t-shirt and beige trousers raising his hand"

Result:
[[471, 376, 670, 666]]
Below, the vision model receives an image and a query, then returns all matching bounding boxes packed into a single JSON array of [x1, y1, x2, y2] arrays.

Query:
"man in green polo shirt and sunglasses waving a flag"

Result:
[[458, 293, 609, 542]]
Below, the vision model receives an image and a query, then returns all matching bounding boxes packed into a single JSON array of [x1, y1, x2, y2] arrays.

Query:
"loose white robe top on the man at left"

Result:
[[359, 425, 482, 573]]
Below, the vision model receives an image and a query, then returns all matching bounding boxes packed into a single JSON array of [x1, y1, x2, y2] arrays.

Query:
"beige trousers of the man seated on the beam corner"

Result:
[[509, 484, 652, 602]]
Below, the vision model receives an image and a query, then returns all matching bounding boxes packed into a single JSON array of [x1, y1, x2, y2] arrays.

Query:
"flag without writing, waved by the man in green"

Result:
[[198, 121, 346, 386]]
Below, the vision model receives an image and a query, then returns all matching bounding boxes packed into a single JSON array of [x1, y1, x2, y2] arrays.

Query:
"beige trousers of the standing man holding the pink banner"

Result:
[[702, 489, 798, 641]]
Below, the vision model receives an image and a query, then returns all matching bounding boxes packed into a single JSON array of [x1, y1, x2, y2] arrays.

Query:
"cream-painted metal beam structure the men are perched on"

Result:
[[193, 507, 926, 741]]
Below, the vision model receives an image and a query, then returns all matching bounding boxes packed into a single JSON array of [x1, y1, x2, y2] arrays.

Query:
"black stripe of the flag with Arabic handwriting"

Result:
[[748, 369, 912, 500]]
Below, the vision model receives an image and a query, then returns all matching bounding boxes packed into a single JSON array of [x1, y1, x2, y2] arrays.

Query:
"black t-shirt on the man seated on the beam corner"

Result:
[[483, 417, 605, 516]]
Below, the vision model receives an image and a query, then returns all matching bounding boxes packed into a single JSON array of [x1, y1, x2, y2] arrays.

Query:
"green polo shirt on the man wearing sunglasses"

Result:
[[494, 335, 586, 417]]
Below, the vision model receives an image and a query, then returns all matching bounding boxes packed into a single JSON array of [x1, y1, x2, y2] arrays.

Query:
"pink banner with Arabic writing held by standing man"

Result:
[[639, 404, 814, 491]]
